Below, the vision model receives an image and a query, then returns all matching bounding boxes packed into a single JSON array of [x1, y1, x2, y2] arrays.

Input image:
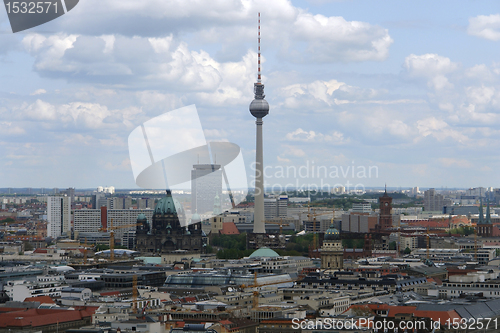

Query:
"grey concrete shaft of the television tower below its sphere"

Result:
[[253, 118, 266, 234]]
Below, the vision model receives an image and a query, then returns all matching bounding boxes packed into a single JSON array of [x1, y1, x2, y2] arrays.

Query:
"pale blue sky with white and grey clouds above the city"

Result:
[[0, 0, 500, 188]]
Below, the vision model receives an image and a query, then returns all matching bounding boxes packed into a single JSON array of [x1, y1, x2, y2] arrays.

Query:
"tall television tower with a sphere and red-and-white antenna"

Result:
[[250, 13, 269, 234]]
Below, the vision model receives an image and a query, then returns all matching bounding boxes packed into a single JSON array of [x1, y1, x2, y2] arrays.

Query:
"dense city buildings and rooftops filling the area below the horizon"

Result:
[[0, 185, 500, 333]]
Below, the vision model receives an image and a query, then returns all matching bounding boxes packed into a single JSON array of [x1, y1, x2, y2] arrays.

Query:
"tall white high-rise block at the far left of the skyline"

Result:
[[47, 197, 71, 238]]
